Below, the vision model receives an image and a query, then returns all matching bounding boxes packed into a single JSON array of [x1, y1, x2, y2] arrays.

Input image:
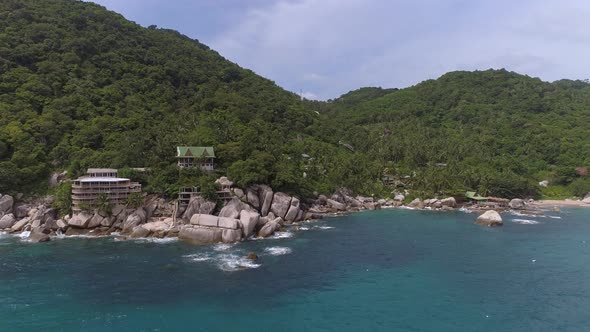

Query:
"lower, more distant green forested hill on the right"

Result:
[[310, 70, 590, 196]]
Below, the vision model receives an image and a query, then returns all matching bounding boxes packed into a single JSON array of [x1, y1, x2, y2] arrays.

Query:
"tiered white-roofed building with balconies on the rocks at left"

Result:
[[72, 168, 141, 211]]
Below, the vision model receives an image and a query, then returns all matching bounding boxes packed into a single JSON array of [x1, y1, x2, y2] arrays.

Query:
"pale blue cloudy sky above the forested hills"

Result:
[[93, 0, 590, 100]]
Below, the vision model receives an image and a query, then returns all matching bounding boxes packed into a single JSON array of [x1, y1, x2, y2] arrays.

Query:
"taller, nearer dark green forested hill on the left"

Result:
[[0, 0, 368, 197]]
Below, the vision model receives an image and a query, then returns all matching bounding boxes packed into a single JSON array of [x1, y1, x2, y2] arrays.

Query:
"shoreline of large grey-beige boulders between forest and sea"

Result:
[[0, 185, 584, 245]]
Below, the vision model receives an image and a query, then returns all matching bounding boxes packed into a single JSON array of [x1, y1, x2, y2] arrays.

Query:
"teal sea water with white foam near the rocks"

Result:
[[0, 209, 590, 331]]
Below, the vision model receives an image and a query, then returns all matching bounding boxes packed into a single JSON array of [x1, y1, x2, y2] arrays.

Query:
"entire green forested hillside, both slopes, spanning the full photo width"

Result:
[[0, 0, 590, 197]]
